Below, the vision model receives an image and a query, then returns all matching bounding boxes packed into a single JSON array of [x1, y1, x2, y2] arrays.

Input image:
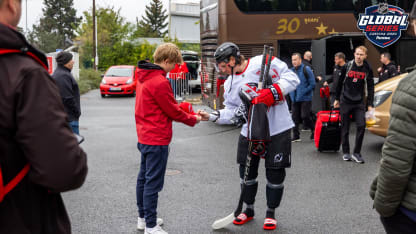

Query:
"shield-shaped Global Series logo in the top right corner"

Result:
[[357, 3, 409, 48]]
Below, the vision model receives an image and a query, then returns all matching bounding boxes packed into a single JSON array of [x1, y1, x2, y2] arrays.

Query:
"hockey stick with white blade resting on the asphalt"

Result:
[[212, 45, 271, 229]]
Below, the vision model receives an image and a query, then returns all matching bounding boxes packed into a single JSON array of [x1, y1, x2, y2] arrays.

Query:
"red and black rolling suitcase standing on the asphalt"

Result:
[[314, 110, 341, 152]]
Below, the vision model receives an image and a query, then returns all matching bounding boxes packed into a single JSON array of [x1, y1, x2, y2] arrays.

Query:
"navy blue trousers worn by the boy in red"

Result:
[[136, 143, 169, 228]]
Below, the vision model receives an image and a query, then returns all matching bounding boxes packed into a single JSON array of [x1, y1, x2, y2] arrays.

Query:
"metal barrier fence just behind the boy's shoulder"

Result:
[[168, 72, 193, 100]]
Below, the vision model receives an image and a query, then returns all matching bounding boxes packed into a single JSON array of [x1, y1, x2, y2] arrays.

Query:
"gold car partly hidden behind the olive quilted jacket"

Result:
[[368, 73, 407, 137]]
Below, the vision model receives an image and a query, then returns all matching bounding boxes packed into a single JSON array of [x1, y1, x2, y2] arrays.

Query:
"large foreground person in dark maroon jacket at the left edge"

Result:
[[0, 0, 87, 234]]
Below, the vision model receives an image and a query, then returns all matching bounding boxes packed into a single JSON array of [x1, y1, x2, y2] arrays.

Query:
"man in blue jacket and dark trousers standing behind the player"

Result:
[[290, 53, 315, 142]]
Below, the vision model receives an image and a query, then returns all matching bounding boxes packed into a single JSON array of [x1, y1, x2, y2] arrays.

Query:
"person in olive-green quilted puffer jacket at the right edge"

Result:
[[370, 67, 416, 234]]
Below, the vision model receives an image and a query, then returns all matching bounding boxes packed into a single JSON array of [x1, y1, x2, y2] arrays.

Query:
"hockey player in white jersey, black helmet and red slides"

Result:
[[198, 42, 299, 230]]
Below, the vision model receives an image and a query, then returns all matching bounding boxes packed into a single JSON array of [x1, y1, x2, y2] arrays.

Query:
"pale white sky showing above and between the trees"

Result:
[[19, 0, 199, 30]]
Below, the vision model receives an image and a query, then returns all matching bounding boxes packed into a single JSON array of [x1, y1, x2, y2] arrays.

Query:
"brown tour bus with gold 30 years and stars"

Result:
[[200, 0, 416, 110]]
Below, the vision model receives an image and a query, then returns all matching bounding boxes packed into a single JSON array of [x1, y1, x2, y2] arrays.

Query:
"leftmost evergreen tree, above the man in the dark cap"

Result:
[[29, 0, 82, 52]]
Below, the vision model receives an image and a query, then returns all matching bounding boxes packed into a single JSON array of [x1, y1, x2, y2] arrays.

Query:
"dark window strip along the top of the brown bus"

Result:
[[234, 0, 415, 13]]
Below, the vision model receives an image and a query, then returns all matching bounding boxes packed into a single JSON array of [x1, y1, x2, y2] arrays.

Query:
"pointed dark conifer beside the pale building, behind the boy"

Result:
[[135, 0, 168, 37]]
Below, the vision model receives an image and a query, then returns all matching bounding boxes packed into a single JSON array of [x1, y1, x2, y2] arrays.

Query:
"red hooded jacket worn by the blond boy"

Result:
[[135, 61, 196, 145]]
